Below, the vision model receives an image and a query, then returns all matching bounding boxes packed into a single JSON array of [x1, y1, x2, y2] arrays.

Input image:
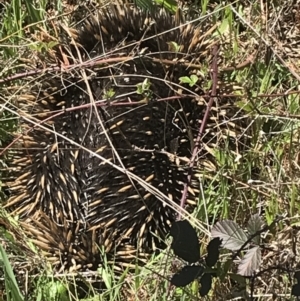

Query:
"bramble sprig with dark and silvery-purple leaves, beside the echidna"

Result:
[[170, 214, 300, 297]]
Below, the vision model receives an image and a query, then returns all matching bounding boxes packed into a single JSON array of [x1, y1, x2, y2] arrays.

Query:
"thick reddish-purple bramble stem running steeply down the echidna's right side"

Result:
[[177, 45, 218, 220]]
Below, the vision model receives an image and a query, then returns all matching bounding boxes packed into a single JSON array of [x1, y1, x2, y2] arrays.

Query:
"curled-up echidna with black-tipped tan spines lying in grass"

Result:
[[6, 4, 248, 269]]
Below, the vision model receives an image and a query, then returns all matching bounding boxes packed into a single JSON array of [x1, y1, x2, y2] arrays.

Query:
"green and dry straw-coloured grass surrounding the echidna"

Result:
[[0, 0, 300, 301]]
